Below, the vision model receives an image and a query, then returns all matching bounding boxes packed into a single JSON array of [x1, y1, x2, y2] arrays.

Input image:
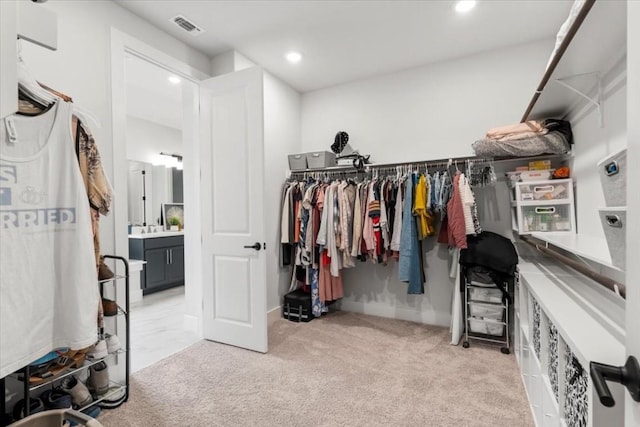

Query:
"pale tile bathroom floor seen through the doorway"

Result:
[[130, 286, 200, 373]]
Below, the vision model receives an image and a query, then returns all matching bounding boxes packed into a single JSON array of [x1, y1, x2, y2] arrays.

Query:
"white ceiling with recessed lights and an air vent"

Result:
[[114, 0, 572, 92]]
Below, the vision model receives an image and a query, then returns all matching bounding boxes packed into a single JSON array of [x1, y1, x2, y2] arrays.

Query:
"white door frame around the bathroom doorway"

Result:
[[111, 27, 211, 337]]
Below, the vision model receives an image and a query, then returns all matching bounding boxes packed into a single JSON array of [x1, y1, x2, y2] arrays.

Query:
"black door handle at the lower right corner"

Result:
[[589, 356, 640, 407]]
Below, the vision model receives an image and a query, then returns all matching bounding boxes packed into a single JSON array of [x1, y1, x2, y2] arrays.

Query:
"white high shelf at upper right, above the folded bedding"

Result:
[[522, 0, 627, 121]]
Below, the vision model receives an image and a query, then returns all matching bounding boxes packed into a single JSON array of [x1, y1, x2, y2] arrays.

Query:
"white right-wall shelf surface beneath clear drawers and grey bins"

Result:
[[531, 232, 621, 271]]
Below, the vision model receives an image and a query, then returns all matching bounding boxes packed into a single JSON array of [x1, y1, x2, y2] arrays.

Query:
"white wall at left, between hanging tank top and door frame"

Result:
[[18, 0, 210, 255]]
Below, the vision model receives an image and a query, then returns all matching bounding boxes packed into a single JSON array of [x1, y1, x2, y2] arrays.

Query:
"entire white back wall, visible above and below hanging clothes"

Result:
[[300, 40, 553, 326]]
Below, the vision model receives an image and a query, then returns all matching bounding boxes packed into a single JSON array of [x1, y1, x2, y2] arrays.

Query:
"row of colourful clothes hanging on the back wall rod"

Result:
[[282, 161, 479, 300]]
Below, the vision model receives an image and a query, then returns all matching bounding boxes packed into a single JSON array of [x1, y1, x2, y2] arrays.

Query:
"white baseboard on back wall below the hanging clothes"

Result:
[[340, 299, 451, 328]]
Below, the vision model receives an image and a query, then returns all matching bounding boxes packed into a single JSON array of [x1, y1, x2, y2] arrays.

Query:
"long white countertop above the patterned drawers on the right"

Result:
[[519, 259, 625, 367]]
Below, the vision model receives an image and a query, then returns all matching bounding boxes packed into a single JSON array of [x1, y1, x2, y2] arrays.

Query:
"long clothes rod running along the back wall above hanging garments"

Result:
[[291, 153, 571, 175]]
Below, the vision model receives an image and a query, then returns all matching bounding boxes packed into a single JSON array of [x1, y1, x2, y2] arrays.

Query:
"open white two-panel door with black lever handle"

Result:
[[200, 68, 267, 353]]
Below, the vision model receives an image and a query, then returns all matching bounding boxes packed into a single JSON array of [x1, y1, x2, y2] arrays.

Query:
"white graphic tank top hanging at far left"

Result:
[[0, 101, 99, 377]]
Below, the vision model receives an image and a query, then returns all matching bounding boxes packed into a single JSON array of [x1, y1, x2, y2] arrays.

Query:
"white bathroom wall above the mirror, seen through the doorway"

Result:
[[127, 116, 183, 163]]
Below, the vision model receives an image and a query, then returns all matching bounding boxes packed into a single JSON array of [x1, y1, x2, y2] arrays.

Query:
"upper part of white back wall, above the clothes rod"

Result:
[[302, 41, 553, 162]]
